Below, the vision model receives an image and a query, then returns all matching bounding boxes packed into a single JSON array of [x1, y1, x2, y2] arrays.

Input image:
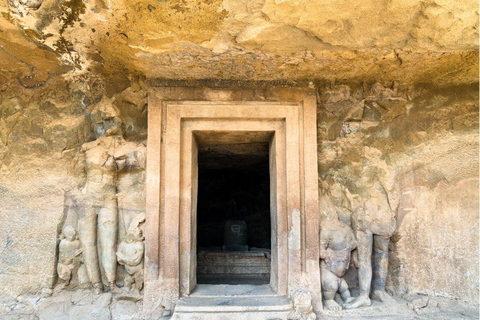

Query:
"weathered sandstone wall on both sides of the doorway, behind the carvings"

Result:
[[0, 78, 479, 304]]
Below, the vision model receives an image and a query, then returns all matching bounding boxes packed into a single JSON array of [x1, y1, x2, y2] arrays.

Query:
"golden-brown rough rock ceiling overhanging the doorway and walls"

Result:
[[0, 0, 479, 89]]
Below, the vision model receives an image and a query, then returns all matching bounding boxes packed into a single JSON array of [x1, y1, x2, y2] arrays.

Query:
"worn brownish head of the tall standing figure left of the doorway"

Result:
[[90, 100, 123, 138]]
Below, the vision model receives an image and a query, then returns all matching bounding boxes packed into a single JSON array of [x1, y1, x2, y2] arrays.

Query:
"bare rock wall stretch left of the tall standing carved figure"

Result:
[[0, 85, 86, 296]]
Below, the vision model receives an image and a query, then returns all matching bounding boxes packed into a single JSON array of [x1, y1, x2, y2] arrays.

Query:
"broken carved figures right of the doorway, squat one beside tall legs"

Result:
[[319, 148, 396, 310]]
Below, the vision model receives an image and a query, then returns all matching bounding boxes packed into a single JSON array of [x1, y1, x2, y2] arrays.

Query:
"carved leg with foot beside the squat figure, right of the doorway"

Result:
[[345, 230, 373, 309]]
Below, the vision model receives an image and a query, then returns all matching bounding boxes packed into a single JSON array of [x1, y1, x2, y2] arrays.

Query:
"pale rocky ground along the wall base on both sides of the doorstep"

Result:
[[0, 290, 478, 320]]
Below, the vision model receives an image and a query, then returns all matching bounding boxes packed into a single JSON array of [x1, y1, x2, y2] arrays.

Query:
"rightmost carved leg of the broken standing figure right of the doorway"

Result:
[[372, 235, 390, 302]]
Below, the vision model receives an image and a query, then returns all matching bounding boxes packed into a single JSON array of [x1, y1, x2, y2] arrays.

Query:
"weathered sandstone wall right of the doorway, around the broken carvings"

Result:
[[318, 83, 479, 304]]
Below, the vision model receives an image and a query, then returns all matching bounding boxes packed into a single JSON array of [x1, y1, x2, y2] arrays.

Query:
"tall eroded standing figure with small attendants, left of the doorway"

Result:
[[52, 103, 145, 293]]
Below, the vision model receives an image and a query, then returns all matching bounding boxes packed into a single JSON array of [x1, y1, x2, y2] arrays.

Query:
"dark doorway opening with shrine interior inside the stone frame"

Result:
[[197, 139, 272, 285]]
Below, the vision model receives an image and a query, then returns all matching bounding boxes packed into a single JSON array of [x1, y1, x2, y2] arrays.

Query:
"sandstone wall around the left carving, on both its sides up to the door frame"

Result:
[[0, 79, 147, 299]]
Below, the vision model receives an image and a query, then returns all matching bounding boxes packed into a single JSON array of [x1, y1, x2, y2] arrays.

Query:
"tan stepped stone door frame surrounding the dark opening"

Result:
[[144, 87, 321, 310]]
